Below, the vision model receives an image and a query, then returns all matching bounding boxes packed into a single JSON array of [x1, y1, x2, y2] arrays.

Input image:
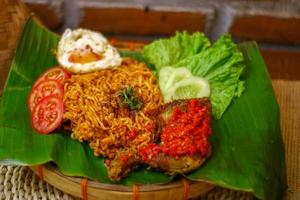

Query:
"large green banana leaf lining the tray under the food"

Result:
[[0, 18, 287, 199]]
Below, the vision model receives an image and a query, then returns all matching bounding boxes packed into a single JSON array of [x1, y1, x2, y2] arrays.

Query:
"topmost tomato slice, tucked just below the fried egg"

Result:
[[33, 66, 71, 88]]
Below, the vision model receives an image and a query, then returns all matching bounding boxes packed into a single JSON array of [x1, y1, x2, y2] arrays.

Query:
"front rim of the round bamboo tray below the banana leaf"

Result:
[[32, 164, 215, 200]]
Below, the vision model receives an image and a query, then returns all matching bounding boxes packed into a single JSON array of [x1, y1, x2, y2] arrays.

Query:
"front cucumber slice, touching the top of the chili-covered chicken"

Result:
[[165, 77, 210, 102]]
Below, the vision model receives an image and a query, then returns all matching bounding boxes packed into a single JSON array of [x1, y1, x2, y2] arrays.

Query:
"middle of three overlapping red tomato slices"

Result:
[[27, 80, 64, 112]]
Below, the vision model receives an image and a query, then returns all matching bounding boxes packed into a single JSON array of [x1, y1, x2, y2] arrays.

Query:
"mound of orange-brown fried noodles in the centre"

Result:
[[64, 58, 163, 158]]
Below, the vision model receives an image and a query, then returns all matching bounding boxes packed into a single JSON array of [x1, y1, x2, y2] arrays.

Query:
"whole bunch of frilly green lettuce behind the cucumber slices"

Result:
[[143, 32, 245, 119]]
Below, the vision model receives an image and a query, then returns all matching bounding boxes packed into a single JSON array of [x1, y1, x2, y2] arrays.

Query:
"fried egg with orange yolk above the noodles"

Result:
[[56, 29, 122, 74]]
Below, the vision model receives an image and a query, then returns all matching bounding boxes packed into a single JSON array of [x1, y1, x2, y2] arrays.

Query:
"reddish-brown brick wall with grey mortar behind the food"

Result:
[[25, 0, 300, 79]]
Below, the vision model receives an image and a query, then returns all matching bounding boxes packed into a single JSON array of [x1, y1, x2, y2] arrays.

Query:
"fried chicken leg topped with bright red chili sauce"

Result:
[[106, 98, 212, 181]]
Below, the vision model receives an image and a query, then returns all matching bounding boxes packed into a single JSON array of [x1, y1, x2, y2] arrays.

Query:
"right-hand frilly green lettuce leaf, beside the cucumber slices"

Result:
[[174, 35, 245, 119]]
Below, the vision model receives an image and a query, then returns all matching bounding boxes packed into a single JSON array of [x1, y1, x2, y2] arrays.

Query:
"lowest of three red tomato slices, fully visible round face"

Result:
[[31, 95, 64, 134]]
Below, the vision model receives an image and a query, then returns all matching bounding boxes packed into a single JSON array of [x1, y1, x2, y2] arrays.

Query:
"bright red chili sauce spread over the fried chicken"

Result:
[[139, 99, 212, 161]]
